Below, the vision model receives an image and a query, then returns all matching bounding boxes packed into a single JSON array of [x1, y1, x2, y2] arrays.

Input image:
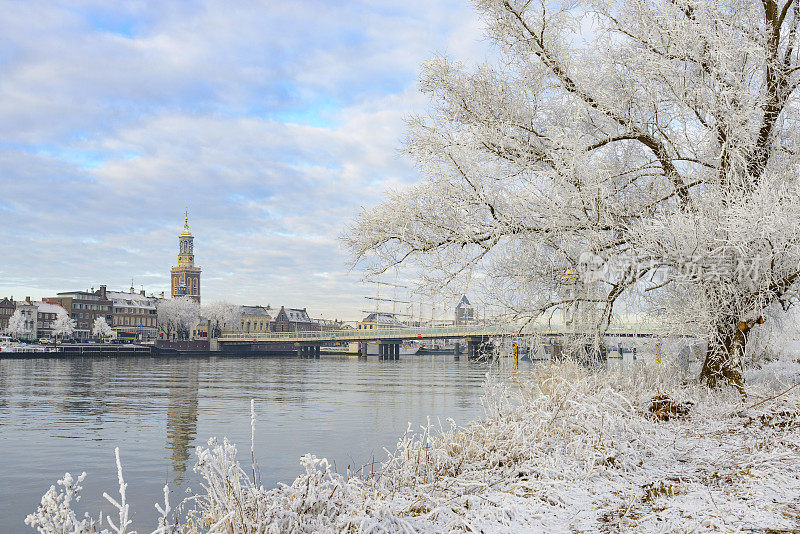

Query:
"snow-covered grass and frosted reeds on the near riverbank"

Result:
[[29, 355, 800, 533]]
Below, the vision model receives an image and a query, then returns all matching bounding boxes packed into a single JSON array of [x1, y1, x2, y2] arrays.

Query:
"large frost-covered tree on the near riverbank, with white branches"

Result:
[[346, 0, 800, 394]]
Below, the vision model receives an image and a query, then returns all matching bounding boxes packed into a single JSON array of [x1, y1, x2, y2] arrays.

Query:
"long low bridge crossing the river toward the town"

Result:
[[218, 323, 666, 359]]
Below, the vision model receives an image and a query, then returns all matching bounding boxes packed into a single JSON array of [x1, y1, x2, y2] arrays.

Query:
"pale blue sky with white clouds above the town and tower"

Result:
[[0, 0, 488, 319]]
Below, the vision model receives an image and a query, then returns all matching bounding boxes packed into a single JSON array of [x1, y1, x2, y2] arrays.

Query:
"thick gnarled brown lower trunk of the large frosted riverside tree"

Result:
[[700, 317, 764, 397]]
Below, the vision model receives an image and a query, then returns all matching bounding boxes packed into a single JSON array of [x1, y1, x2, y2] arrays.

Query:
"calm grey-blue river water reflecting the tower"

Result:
[[0, 356, 496, 533]]
